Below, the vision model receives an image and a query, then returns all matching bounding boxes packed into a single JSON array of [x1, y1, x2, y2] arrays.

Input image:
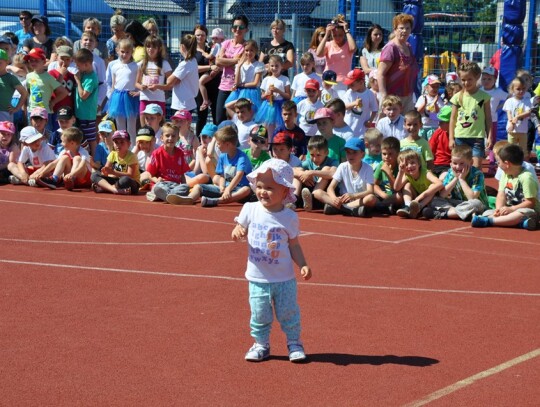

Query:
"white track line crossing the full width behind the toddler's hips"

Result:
[[0, 259, 540, 297]]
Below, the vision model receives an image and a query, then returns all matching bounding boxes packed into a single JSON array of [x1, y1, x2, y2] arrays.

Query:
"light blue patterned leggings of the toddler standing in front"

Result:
[[249, 279, 300, 344]]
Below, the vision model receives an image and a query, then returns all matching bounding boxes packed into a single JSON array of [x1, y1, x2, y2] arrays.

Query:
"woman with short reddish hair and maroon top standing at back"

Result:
[[377, 14, 418, 112]]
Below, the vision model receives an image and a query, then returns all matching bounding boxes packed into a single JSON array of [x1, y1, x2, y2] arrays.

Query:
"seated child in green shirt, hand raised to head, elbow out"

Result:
[[394, 149, 443, 219]]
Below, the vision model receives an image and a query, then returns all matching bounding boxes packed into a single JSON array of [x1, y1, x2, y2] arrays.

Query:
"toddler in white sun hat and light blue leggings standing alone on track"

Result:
[[232, 158, 311, 362]]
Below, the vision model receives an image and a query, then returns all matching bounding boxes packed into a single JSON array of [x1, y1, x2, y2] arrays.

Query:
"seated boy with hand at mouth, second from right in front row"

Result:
[[422, 145, 488, 221]]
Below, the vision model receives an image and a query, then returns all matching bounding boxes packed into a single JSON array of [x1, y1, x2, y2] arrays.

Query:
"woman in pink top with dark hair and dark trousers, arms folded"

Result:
[[215, 16, 249, 123]]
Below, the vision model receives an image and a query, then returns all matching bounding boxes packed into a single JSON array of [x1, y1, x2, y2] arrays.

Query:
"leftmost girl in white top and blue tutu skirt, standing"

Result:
[[107, 38, 139, 145]]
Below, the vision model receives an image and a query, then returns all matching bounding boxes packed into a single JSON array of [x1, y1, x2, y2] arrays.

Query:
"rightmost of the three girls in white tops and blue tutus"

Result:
[[255, 55, 291, 138]]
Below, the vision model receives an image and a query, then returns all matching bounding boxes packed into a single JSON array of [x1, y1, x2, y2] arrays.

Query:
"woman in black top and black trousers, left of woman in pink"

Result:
[[193, 24, 221, 135]]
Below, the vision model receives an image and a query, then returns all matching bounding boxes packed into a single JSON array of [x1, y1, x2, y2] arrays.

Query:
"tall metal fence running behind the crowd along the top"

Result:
[[0, 0, 540, 75]]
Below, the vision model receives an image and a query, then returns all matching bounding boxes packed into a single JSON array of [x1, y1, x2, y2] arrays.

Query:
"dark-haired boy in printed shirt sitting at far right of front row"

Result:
[[471, 144, 540, 230]]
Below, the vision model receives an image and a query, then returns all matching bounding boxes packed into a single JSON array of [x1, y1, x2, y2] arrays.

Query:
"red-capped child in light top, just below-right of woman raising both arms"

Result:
[[343, 68, 379, 138]]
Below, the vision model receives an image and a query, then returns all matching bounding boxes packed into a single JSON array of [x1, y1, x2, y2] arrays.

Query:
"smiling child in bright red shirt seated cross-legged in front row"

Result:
[[141, 123, 189, 202]]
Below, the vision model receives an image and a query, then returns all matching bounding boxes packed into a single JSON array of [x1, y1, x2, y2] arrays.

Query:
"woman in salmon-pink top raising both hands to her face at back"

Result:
[[317, 14, 356, 98]]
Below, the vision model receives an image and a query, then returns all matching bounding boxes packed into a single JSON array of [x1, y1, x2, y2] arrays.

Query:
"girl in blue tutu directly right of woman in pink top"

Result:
[[225, 40, 265, 117]]
